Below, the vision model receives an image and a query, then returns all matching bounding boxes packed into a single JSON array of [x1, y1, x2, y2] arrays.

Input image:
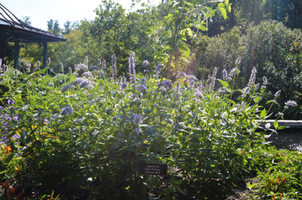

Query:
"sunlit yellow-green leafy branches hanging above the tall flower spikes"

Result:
[[151, 0, 231, 77]]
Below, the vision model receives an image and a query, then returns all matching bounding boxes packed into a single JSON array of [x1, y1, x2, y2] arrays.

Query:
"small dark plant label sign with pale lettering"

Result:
[[138, 163, 168, 175]]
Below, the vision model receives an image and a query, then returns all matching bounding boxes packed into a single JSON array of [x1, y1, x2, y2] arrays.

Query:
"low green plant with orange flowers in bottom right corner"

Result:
[[246, 147, 302, 199]]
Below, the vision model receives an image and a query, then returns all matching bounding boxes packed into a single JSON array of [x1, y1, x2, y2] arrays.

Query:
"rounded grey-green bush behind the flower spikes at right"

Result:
[[194, 21, 302, 119]]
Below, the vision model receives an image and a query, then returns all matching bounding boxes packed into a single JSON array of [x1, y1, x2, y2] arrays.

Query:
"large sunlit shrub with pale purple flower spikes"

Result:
[[0, 52, 295, 199]]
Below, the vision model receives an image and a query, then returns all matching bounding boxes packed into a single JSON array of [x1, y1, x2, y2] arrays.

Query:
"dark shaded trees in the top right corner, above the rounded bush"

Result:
[[204, 0, 302, 37]]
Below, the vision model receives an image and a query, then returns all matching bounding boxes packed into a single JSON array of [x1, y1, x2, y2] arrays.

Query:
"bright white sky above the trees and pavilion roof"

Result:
[[0, 0, 161, 30]]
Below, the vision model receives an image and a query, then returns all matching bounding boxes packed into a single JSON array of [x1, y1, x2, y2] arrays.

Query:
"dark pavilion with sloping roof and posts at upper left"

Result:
[[0, 3, 66, 69]]
